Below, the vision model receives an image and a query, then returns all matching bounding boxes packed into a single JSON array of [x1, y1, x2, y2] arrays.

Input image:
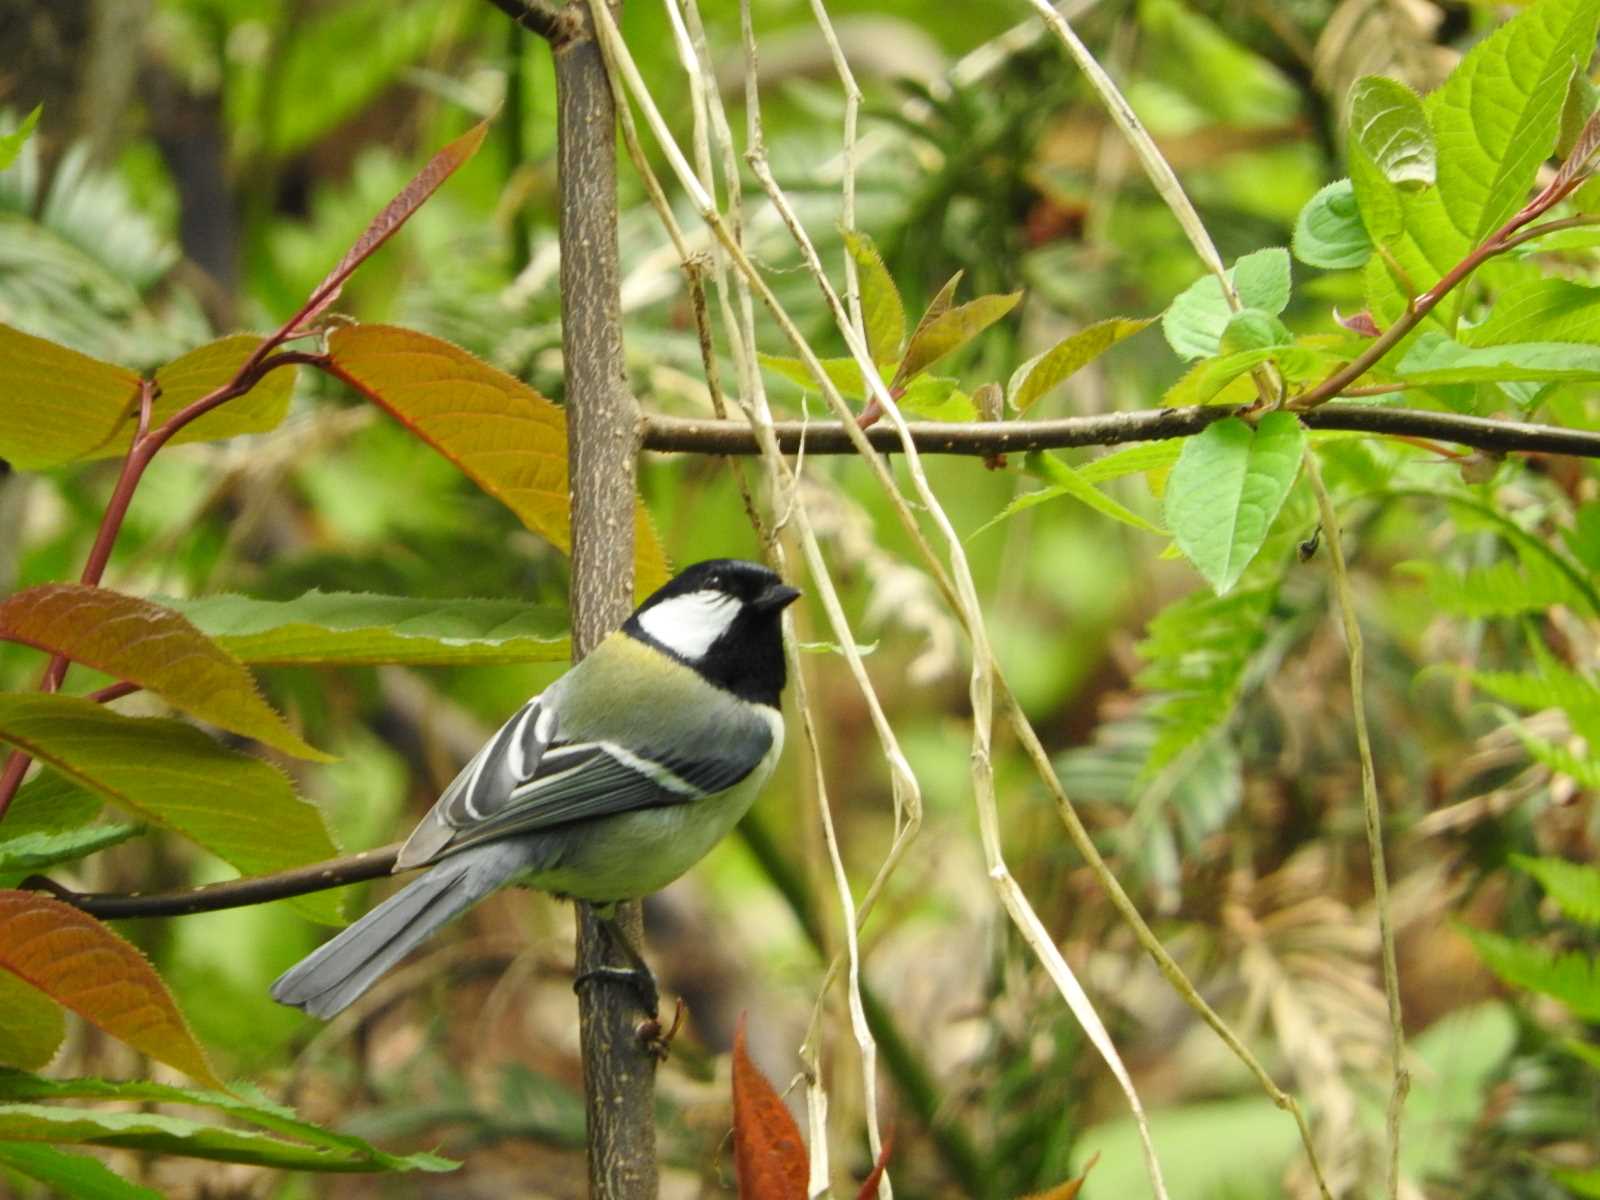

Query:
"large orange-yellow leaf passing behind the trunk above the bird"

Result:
[[328, 325, 667, 592]]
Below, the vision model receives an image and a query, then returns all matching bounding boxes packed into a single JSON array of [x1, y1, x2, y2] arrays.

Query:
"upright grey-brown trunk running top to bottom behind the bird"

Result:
[[554, 2, 658, 1200]]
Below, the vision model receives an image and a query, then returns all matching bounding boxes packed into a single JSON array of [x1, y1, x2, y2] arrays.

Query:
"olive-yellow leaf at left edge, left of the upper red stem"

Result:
[[0, 325, 139, 470]]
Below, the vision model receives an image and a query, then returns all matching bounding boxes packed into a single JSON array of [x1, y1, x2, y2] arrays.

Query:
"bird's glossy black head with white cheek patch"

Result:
[[622, 558, 800, 707]]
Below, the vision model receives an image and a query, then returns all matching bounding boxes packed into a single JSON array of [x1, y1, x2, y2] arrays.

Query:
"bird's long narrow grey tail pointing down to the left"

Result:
[[272, 843, 525, 1019]]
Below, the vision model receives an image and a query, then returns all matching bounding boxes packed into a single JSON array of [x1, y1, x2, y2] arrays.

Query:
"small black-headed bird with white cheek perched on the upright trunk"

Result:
[[272, 558, 800, 1018]]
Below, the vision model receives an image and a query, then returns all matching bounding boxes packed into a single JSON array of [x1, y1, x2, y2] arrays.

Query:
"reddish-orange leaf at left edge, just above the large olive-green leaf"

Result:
[[0, 584, 330, 762]]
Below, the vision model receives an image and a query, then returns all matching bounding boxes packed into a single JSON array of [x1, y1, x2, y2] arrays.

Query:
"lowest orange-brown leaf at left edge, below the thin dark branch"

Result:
[[0, 890, 222, 1088]]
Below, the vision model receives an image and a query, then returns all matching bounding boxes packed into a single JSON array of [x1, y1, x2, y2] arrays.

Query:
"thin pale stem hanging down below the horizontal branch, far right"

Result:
[[1306, 451, 1411, 1200]]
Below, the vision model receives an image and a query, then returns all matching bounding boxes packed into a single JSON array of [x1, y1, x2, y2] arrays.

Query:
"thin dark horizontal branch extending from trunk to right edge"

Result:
[[643, 403, 1600, 458]]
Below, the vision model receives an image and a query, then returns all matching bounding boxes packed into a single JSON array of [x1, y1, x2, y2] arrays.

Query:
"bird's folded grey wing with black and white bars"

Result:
[[385, 698, 773, 870]]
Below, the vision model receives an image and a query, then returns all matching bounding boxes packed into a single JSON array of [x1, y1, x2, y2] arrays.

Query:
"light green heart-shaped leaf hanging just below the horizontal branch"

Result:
[[1166, 413, 1306, 595]]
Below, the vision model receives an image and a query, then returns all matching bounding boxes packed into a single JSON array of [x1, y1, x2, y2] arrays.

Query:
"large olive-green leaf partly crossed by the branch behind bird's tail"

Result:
[[0, 693, 339, 923]]
